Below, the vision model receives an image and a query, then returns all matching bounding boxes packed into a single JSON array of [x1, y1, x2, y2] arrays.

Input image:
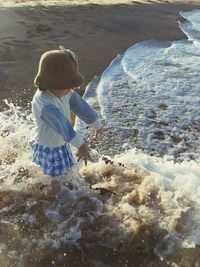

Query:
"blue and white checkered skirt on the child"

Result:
[[29, 140, 74, 176]]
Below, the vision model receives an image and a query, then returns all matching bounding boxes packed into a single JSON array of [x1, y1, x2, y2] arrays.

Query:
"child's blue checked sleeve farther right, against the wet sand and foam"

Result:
[[69, 91, 102, 130]]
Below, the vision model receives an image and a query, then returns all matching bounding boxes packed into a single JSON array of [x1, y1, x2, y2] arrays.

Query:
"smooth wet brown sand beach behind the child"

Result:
[[0, 0, 200, 107]]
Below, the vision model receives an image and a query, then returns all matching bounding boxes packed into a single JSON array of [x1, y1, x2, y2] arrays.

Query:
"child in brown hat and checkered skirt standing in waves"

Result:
[[29, 46, 103, 176]]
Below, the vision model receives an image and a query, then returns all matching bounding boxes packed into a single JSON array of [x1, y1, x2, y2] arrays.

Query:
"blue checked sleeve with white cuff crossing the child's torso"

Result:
[[41, 105, 84, 148]]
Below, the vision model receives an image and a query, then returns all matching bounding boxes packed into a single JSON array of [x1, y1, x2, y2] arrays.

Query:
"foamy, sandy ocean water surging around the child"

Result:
[[0, 10, 200, 267]]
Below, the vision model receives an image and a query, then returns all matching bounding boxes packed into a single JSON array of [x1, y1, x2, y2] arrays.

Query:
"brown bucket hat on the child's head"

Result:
[[34, 46, 84, 90]]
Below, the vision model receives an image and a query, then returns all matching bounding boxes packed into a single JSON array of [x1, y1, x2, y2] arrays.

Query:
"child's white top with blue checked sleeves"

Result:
[[32, 90, 102, 148]]
